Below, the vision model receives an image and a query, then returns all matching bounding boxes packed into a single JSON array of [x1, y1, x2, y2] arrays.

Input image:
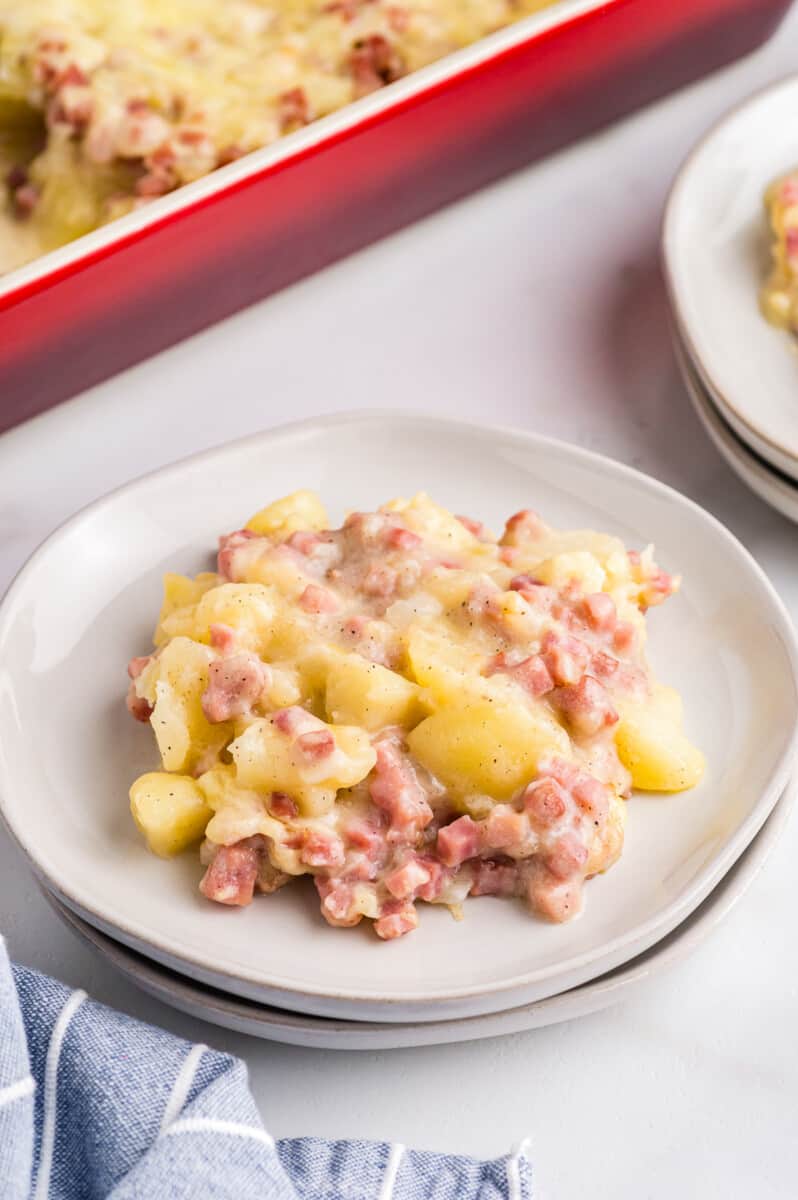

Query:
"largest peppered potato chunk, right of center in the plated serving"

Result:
[[407, 698, 570, 799]]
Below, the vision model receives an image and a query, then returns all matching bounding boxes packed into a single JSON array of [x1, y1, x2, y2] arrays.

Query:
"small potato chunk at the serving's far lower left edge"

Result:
[[130, 770, 214, 858]]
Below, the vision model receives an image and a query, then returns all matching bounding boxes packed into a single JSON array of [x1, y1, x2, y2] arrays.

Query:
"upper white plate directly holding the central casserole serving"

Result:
[[0, 413, 798, 1021]]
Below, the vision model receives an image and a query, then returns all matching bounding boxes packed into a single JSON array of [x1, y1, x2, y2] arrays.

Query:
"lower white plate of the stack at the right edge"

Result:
[[673, 332, 798, 522]]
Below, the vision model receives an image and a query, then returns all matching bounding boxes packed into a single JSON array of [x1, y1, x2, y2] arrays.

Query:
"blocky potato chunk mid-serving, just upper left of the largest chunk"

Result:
[[325, 654, 424, 731]]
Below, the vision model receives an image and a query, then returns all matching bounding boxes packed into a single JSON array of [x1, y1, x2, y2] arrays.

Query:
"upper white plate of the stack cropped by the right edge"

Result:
[[664, 77, 798, 478]]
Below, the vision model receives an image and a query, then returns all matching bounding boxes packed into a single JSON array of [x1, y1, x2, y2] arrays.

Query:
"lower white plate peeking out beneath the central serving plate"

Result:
[[44, 780, 796, 1050]]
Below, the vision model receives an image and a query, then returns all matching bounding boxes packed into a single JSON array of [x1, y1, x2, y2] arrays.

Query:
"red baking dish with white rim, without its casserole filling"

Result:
[[0, 0, 790, 428]]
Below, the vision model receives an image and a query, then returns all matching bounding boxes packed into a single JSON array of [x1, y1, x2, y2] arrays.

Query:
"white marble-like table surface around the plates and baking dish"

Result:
[[0, 11, 798, 1200]]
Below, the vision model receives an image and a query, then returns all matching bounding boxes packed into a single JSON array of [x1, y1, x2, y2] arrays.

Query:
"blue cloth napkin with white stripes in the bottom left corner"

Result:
[[0, 938, 532, 1200]]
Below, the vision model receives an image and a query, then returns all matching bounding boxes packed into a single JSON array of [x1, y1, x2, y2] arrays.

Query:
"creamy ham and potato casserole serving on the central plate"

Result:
[[127, 491, 703, 938]]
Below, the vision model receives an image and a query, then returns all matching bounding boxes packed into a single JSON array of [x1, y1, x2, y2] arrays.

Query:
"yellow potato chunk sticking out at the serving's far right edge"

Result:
[[616, 688, 704, 792]]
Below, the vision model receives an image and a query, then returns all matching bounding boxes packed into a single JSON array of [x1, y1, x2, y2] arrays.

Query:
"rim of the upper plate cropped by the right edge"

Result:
[[660, 71, 798, 480]]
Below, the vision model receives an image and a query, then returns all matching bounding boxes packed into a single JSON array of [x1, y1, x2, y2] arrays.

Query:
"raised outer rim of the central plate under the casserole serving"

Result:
[[0, 408, 798, 1021]]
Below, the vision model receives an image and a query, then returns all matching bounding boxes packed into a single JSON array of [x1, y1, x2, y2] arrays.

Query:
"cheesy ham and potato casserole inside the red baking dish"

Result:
[[0, 0, 552, 270]]
